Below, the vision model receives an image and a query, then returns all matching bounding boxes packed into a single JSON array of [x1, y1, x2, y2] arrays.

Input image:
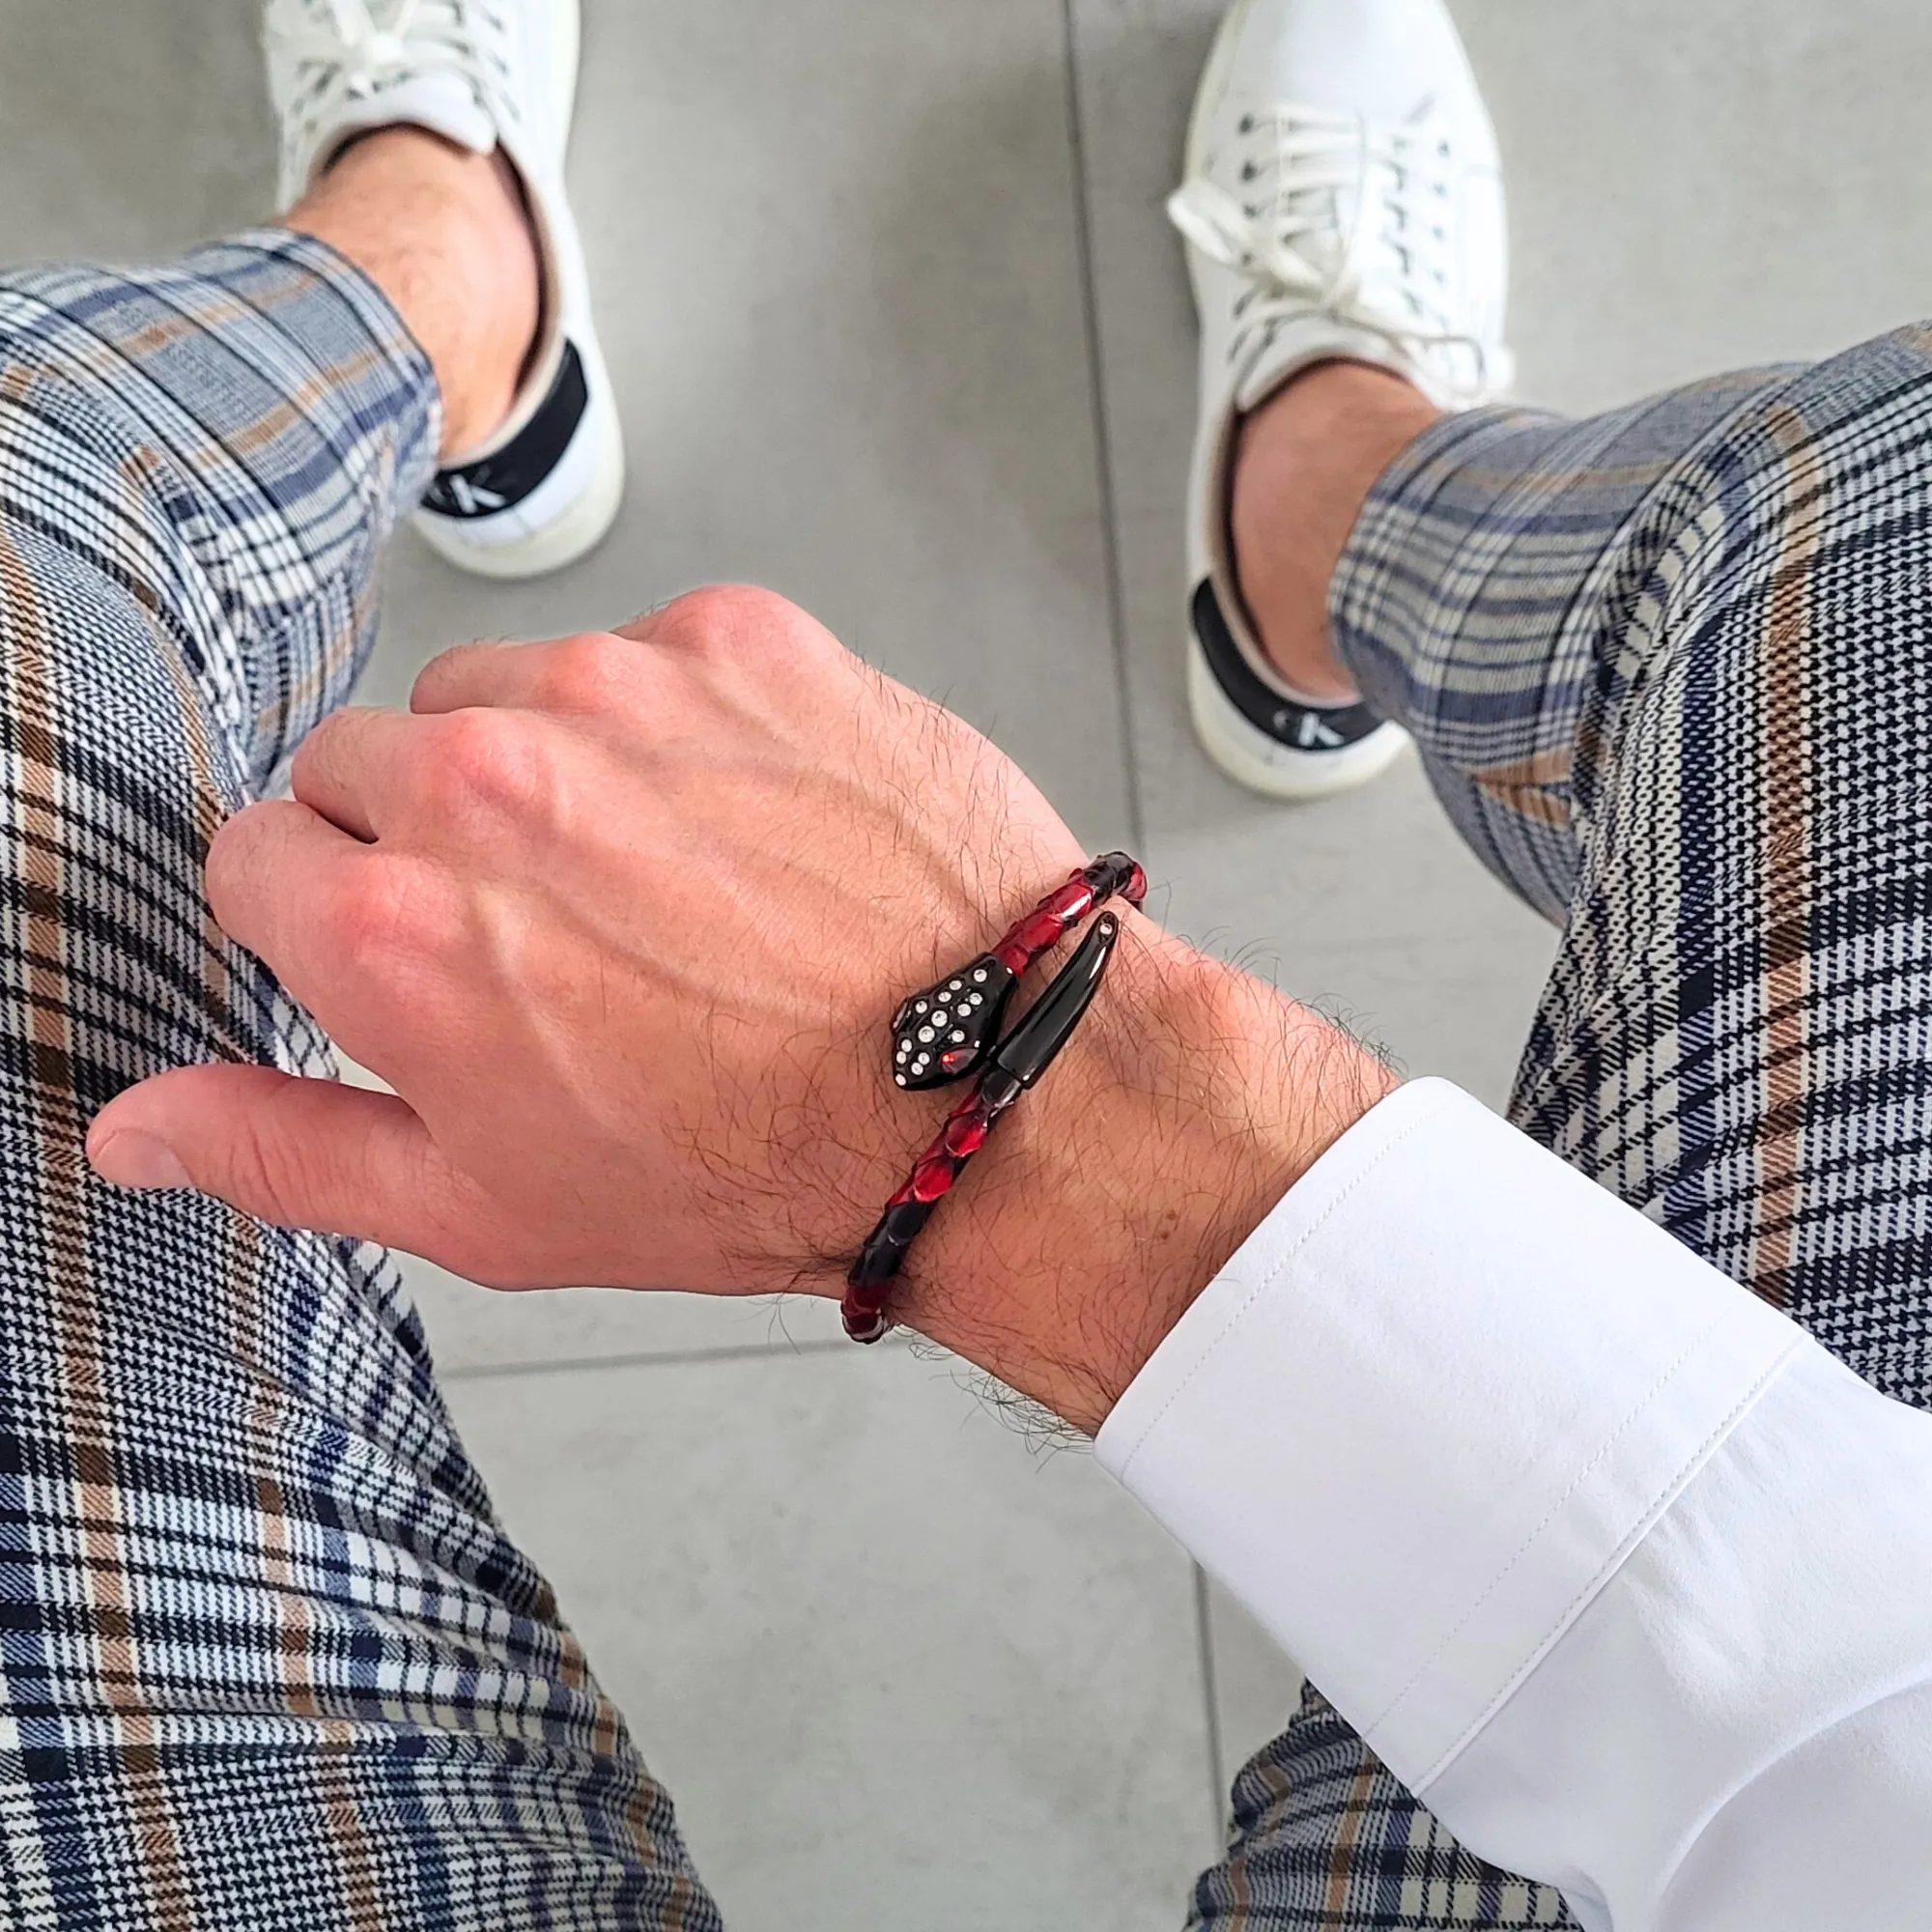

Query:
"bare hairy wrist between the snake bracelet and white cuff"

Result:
[[900, 914, 1395, 1434]]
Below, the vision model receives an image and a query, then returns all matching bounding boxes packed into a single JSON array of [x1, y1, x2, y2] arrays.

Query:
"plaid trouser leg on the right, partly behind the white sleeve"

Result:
[[1192, 328, 1932, 1932]]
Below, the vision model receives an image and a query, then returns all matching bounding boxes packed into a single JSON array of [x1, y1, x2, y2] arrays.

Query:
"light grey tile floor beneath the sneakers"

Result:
[[0, 0, 1932, 1932]]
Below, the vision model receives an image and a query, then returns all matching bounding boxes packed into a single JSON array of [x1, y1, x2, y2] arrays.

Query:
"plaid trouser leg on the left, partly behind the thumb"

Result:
[[0, 234, 719, 1932]]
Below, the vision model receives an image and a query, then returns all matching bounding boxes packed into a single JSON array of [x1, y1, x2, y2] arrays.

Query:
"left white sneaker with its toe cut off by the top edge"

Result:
[[265, 0, 624, 578]]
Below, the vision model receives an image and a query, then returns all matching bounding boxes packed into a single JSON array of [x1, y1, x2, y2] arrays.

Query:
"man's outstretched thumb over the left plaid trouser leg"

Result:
[[87, 1065, 487, 1258]]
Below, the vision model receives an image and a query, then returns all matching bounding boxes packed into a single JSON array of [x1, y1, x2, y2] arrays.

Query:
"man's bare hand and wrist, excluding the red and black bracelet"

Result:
[[89, 589, 1387, 1426]]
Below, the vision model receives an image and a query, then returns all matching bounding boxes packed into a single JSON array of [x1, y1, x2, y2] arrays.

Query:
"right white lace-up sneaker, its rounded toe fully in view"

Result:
[[1167, 0, 1511, 798]]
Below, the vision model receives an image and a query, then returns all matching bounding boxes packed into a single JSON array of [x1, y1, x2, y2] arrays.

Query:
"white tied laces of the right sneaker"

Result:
[[1167, 102, 1490, 381]]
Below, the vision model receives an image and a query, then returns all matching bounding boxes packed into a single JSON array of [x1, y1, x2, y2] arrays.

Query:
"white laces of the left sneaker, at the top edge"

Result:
[[269, 0, 510, 135]]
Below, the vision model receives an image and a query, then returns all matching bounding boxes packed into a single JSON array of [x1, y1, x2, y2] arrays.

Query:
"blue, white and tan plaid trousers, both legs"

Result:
[[0, 232, 1932, 1932]]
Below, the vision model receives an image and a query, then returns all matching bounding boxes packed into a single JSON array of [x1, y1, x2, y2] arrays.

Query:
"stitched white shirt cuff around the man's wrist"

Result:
[[1097, 1080, 1804, 1793]]
